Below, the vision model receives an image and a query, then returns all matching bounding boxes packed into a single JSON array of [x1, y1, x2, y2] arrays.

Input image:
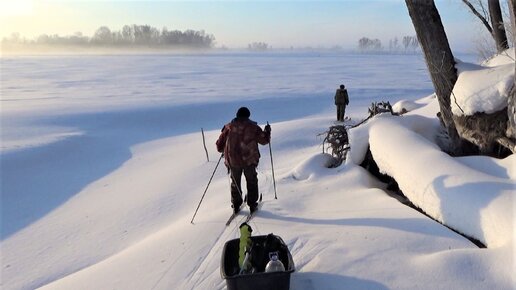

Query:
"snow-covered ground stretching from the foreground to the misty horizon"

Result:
[[0, 53, 516, 289]]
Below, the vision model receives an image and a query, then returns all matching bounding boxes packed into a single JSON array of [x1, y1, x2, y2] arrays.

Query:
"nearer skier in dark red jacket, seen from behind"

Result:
[[216, 107, 271, 212]]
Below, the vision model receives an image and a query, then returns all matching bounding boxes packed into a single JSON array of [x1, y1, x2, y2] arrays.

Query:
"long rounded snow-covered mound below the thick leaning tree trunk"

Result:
[[369, 116, 514, 247]]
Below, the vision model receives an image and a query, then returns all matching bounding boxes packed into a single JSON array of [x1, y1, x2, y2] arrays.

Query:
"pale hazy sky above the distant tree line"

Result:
[[0, 0, 488, 51]]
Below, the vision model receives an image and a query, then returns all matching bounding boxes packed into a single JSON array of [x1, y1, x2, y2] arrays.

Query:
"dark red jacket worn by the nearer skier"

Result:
[[216, 118, 271, 167]]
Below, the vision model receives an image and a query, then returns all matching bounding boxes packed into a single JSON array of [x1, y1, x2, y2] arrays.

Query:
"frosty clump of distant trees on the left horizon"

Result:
[[2, 24, 215, 48]]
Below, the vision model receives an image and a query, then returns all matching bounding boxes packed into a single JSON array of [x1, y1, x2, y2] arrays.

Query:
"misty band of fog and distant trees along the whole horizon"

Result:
[[1, 24, 480, 56]]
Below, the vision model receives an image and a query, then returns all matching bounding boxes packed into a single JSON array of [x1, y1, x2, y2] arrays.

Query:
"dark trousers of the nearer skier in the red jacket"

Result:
[[229, 165, 258, 208]]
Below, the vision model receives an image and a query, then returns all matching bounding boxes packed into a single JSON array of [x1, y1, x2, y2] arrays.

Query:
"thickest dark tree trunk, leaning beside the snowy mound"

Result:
[[405, 0, 461, 154]]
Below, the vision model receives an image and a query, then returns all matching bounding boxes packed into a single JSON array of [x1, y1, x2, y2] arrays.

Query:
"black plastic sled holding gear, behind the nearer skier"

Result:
[[220, 234, 295, 290]]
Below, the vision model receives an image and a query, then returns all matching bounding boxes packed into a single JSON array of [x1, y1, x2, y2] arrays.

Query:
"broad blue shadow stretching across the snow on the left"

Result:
[[0, 96, 331, 240]]
